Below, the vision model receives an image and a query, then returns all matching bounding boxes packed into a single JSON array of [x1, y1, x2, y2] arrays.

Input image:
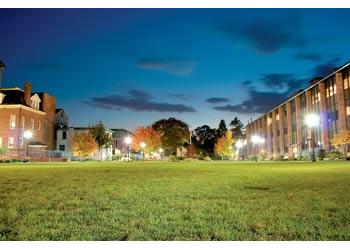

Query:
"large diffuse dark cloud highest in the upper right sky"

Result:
[[219, 12, 307, 54]]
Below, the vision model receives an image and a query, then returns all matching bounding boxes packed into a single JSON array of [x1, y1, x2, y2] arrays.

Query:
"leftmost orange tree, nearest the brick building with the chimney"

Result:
[[71, 131, 98, 158]]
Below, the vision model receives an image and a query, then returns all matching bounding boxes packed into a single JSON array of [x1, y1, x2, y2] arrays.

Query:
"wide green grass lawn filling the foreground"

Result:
[[0, 162, 350, 240]]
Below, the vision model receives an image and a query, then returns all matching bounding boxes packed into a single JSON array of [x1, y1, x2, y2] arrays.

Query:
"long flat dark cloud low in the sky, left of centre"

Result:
[[83, 90, 196, 113]]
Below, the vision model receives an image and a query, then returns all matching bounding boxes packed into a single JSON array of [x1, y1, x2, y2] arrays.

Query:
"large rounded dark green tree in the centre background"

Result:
[[152, 118, 190, 155]]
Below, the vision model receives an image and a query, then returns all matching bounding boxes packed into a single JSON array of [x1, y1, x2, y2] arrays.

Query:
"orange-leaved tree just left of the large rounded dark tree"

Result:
[[132, 127, 162, 152]]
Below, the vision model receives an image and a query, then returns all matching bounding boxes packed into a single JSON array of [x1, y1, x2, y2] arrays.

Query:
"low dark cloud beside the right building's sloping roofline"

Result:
[[214, 88, 286, 114]]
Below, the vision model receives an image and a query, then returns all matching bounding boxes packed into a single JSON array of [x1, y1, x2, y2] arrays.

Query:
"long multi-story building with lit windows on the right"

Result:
[[246, 62, 350, 159]]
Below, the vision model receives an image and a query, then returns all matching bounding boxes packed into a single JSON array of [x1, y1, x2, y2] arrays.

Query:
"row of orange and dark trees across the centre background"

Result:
[[132, 117, 243, 157]]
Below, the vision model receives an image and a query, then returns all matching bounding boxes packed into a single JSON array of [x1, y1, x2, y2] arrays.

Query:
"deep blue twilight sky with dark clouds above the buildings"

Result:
[[0, 9, 350, 129]]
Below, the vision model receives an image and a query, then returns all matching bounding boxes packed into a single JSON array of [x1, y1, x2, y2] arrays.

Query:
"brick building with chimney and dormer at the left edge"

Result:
[[0, 82, 56, 158]]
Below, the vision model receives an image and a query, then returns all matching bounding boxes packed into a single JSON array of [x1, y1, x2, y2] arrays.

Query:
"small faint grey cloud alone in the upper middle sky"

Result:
[[136, 59, 197, 76]]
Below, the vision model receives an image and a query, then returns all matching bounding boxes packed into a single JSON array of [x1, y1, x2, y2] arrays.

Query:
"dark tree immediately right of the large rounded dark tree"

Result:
[[192, 125, 217, 156]]
